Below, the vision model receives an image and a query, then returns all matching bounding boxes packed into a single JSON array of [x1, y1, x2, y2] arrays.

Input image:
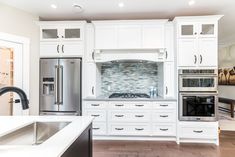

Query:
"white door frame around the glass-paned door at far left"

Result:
[[0, 32, 30, 115]]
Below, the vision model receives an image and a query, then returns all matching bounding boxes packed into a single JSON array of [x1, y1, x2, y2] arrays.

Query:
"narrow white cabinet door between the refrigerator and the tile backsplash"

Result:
[[84, 63, 97, 97]]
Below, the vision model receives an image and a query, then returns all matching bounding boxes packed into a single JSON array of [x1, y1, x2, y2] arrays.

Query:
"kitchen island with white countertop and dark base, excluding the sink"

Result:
[[0, 116, 93, 157]]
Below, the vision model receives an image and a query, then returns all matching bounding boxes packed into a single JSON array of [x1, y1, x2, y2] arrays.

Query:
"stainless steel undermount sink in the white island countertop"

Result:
[[0, 122, 70, 145]]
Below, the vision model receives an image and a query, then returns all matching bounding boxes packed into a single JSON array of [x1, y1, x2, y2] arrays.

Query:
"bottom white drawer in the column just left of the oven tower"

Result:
[[153, 123, 176, 136]]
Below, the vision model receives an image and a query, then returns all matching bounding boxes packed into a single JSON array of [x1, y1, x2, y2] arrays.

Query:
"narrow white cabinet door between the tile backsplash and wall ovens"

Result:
[[163, 62, 176, 98]]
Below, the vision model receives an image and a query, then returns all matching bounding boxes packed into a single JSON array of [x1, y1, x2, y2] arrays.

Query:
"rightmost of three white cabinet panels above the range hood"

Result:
[[142, 24, 165, 49]]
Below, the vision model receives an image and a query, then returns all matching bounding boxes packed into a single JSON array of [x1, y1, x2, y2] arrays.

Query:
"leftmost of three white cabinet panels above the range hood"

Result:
[[95, 25, 117, 49]]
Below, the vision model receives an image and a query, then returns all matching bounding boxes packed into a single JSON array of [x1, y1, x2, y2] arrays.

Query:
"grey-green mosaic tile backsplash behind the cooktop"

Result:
[[101, 62, 158, 96]]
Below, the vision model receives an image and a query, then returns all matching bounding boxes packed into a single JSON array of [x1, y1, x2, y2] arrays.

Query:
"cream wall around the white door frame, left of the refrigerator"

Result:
[[0, 3, 39, 115]]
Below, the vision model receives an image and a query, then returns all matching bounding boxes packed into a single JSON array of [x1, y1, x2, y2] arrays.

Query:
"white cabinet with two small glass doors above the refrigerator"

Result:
[[40, 22, 84, 41]]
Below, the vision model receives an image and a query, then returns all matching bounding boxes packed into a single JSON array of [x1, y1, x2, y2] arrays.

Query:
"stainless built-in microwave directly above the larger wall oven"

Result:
[[179, 70, 218, 92]]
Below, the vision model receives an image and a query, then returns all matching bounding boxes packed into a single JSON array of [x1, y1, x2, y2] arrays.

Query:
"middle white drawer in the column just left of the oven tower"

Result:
[[152, 110, 176, 122]]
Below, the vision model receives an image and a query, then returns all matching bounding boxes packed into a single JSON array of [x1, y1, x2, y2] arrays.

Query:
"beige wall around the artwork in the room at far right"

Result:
[[218, 44, 235, 109]]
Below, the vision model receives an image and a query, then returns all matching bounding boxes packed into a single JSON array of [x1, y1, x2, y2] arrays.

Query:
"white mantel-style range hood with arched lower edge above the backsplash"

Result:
[[93, 49, 167, 63]]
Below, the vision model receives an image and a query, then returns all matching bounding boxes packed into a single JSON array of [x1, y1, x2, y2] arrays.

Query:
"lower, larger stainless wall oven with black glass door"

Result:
[[179, 92, 218, 121]]
